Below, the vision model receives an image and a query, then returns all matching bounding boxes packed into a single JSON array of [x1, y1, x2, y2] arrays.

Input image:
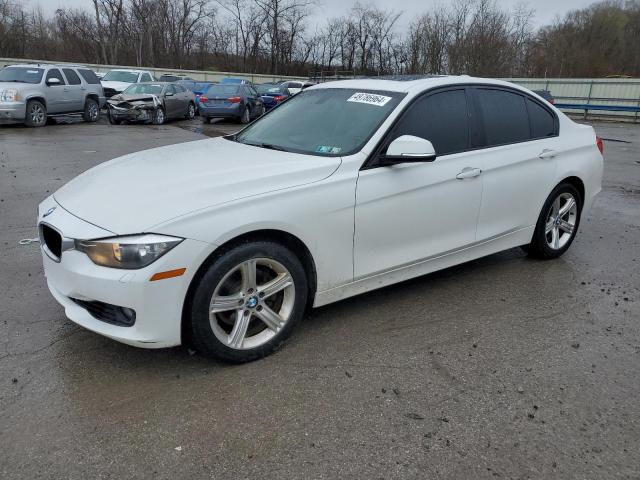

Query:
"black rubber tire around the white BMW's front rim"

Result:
[[185, 241, 308, 363]]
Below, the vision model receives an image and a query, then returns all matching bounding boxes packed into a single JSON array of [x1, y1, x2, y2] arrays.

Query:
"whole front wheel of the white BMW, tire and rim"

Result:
[[188, 242, 308, 363]]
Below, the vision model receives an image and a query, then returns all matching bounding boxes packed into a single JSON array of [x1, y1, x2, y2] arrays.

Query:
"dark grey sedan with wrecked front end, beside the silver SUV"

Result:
[[107, 82, 196, 125]]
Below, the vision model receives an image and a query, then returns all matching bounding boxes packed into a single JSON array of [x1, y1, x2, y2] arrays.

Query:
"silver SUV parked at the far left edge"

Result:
[[0, 65, 105, 127]]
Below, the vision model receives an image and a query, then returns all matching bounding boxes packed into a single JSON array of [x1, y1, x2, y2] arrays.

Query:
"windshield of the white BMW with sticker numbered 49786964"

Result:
[[235, 88, 405, 156]]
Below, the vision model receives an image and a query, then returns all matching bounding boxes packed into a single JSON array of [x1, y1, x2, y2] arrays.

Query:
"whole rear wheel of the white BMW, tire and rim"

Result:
[[525, 183, 582, 259]]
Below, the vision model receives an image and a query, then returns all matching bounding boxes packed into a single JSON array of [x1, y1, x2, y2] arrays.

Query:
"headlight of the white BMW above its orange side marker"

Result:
[[75, 233, 183, 269]]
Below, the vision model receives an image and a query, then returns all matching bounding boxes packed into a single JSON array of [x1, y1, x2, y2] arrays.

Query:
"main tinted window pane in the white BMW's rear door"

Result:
[[476, 89, 531, 147]]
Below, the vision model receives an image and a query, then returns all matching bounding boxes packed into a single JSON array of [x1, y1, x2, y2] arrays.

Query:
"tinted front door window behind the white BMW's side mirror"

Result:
[[392, 89, 469, 156]]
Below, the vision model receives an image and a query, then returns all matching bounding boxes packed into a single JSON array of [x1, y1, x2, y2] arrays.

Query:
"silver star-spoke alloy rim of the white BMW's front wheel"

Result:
[[209, 258, 295, 349]]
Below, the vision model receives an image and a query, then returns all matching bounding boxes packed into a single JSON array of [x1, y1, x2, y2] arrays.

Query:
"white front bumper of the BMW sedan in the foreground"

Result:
[[38, 197, 211, 348]]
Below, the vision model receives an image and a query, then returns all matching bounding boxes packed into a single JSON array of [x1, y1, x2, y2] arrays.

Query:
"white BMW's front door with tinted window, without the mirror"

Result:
[[354, 88, 482, 279]]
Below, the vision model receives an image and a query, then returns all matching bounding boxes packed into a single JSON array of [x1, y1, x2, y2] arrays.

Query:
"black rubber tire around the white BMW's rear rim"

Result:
[[522, 183, 583, 260]]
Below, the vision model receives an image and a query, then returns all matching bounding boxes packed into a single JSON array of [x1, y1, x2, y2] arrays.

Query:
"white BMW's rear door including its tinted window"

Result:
[[470, 87, 561, 241]]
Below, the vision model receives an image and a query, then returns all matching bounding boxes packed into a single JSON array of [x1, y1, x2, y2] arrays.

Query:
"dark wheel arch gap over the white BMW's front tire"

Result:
[[181, 229, 317, 345]]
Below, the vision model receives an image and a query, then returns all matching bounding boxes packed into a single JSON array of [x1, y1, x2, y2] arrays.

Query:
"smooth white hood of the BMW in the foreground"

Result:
[[54, 138, 341, 235]]
